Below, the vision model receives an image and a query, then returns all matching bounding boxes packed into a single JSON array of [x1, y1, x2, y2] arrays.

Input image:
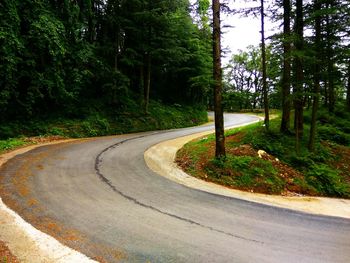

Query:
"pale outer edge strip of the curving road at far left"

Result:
[[0, 139, 97, 263]]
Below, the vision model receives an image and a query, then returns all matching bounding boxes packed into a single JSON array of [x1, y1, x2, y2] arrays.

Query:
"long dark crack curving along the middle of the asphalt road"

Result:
[[95, 133, 264, 244]]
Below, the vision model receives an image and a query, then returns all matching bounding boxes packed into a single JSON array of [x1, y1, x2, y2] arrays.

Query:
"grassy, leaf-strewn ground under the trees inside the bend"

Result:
[[177, 108, 350, 198]]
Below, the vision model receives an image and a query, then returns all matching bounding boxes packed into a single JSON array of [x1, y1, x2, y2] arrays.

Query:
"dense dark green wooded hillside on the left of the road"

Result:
[[0, 0, 212, 142]]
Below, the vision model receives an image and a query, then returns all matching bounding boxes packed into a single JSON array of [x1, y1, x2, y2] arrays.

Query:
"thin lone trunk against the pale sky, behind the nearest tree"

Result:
[[260, 0, 270, 130]]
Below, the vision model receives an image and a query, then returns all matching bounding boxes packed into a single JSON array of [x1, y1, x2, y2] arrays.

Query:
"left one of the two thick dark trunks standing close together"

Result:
[[280, 0, 291, 133]]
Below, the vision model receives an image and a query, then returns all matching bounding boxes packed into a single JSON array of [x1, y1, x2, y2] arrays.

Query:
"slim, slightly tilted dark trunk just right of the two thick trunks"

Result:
[[308, 0, 321, 151]]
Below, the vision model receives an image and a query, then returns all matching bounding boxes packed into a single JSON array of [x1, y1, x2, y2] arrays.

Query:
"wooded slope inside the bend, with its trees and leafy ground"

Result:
[[177, 0, 350, 198]]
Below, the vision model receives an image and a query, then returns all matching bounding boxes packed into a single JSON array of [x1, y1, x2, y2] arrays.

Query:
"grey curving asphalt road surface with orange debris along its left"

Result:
[[0, 114, 350, 263]]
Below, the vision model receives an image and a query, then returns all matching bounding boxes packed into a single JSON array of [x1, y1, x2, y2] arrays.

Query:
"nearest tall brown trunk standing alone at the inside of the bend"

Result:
[[212, 0, 226, 158]]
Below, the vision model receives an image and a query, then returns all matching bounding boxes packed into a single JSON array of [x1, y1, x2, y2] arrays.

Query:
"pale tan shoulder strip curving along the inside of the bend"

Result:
[[144, 132, 350, 218]]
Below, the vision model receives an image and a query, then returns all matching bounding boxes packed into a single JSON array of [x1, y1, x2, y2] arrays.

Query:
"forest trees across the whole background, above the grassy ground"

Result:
[[0, 0, 350, 137]]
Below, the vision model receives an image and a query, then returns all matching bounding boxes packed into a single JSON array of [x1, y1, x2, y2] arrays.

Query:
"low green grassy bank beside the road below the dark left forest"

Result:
[[0, 101, 208, 153]]
